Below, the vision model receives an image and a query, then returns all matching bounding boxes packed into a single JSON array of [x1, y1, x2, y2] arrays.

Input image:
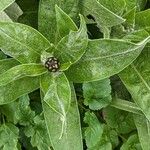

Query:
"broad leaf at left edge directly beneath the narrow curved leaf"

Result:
[[0, 77, 39, 105]]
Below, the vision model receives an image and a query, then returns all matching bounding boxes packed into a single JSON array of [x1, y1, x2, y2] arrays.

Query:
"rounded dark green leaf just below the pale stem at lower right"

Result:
[[103, 107, 135, 134]]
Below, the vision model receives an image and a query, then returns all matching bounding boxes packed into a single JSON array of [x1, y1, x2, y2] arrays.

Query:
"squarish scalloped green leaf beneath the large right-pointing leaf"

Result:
[[83, 79, 111, 110]]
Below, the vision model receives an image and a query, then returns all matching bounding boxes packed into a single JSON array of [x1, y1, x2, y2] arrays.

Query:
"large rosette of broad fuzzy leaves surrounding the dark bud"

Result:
[[0, 1, 150, 150]]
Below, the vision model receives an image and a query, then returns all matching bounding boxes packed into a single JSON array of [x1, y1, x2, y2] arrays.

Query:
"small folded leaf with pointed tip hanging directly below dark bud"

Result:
[[41, 73, 71, 115]]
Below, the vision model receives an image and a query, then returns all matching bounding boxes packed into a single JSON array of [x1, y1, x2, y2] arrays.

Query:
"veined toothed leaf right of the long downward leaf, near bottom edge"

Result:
[[84, 112, 104, 149]]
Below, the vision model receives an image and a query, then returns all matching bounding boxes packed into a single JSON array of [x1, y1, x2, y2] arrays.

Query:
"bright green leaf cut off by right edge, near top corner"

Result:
[[135, 9, 150, 29]]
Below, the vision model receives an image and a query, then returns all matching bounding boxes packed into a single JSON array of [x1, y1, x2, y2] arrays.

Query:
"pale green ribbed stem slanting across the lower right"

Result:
[[110, 98, 143, 115]]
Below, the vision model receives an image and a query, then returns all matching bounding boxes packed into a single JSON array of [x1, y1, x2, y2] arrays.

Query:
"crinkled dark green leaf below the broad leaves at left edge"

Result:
[[1, 95, 35, 126]]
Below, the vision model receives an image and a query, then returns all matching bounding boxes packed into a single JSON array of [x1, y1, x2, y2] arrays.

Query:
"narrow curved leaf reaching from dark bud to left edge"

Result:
[[0, 64, 47, 86]]
